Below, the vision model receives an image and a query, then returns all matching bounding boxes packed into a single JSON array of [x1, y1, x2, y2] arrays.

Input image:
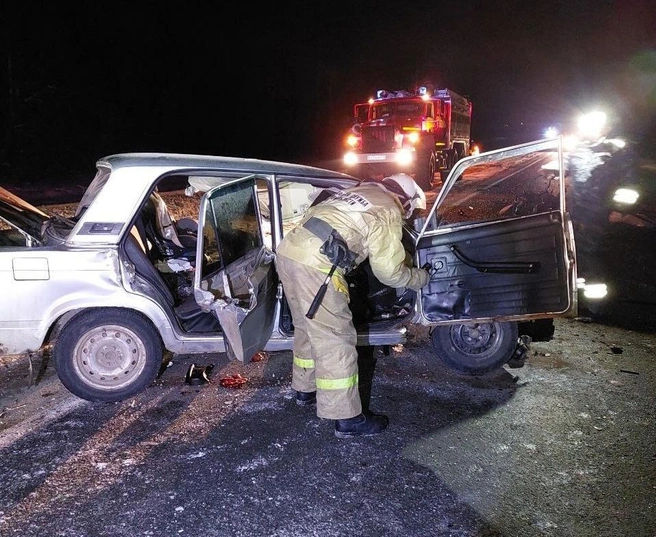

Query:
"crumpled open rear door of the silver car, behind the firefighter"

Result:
[[194, 176, 278, 362]]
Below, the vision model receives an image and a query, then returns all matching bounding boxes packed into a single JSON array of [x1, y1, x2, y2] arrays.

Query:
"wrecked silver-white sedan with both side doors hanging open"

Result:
[[0, 139, 577, 401]]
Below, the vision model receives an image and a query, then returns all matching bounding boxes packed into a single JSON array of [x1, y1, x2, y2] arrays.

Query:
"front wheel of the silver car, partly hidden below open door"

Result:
[[431, 322, 519, 375]]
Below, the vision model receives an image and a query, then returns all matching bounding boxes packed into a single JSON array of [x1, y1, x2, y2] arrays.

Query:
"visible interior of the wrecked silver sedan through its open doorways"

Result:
[[118, 172, 416, 340]]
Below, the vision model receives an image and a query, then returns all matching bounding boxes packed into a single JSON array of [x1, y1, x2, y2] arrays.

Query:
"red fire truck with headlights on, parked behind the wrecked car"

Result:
[[344, 86, 472, 190]]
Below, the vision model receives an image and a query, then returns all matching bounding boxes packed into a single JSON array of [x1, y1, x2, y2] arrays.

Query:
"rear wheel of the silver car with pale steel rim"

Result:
[[53, 309, 163, 402]]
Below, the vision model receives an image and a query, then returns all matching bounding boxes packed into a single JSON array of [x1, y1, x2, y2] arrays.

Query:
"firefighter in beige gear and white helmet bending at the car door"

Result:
[[276, 174, 429, 438]]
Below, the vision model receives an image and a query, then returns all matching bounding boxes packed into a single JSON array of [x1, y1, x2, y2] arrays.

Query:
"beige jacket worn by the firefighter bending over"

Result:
[[277, 183, 429, 290]]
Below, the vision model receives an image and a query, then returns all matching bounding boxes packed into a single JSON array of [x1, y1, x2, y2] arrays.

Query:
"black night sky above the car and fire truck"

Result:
[[0, 0, 656, 181]]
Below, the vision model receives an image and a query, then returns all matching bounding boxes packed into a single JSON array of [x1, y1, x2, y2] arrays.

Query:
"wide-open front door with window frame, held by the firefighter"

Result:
[[415, 138, 577, 325]]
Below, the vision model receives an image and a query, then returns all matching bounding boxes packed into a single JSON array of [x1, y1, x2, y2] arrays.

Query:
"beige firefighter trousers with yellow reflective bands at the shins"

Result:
[[276, 254, 362, 420]]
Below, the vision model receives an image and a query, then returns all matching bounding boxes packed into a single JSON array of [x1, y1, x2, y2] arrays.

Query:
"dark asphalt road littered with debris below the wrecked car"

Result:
[[0, 320, 656, 537]]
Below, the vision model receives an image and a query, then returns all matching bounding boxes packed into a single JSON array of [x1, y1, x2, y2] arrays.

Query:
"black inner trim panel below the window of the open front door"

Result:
[[419, 212, 569, 322]]
